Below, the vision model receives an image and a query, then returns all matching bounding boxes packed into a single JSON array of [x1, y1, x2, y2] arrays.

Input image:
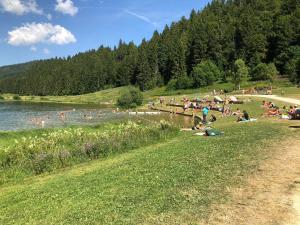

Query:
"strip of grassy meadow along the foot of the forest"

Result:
[[1, 79, 300, 105]]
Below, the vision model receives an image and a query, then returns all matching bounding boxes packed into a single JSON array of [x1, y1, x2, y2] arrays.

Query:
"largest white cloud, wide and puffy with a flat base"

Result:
[[8, 23, 76, 46]]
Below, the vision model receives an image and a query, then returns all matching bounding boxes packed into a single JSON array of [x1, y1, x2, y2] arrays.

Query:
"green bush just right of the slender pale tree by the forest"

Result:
[[252, 63, 278, 81]]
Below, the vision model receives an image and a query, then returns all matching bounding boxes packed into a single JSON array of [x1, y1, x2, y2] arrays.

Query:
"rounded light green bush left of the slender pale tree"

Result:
[[191, 60, 221, 88]]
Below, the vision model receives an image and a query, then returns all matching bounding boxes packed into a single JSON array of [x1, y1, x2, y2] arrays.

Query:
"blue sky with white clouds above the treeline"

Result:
[[0, 0, 209, 66]]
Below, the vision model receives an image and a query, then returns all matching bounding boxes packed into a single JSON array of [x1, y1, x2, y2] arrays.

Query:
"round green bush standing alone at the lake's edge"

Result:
[[117, 88, 143, 109]]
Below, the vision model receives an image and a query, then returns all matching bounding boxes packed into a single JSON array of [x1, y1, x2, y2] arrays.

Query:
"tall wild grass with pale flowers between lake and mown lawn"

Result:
[[0, 121, 178, 184]]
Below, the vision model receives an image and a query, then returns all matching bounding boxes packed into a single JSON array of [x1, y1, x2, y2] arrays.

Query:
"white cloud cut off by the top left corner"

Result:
[[0, 0, 43, 15]]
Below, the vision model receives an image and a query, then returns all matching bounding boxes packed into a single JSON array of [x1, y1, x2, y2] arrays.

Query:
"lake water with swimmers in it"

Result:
[[0, 102, 191, 131]]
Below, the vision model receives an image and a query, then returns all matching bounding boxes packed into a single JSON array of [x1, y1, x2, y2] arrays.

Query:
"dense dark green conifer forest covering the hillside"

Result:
[[0, 0, 300, 96]]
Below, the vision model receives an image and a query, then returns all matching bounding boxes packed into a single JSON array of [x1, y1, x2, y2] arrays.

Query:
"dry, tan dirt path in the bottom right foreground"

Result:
[[205, 136, 300, 225]]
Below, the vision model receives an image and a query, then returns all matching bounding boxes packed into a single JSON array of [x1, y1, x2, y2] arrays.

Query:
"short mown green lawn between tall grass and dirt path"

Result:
[[0, 119, 298, 224]]
